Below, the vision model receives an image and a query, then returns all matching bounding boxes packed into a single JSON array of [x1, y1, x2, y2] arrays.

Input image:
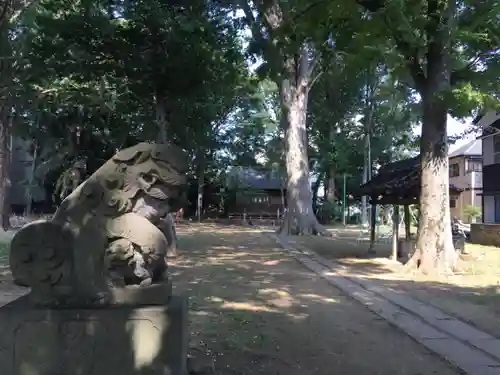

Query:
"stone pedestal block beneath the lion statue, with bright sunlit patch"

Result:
[[0, 296, 188, 375]]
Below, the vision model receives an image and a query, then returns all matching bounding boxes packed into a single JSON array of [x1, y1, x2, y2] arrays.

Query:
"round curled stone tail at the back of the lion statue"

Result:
[[10, 220, 73, 289]]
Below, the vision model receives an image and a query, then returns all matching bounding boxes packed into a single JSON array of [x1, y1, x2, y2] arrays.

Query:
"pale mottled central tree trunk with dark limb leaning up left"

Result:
[[240, 0, 328, 235]]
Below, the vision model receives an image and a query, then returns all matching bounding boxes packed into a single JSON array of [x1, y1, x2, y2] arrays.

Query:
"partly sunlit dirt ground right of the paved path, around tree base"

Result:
[[293, 230, 500, 338]]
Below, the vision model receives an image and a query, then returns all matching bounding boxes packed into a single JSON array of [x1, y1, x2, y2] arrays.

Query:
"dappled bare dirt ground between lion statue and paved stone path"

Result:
[[171, 227, 458, 375]]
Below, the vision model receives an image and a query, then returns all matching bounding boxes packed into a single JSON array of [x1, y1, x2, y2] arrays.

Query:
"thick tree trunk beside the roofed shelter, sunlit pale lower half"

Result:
[[408, 0, 458, 274]]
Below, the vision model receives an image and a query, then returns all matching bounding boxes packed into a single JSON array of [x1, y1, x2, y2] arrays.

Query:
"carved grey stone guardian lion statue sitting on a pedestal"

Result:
[[10, 143, 188, 305]]
